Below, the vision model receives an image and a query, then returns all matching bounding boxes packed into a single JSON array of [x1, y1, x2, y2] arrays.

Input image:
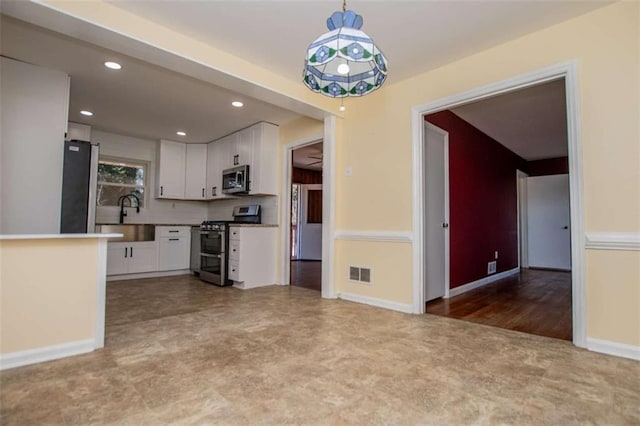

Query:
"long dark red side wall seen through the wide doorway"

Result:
[[425, 111, 526, 288]]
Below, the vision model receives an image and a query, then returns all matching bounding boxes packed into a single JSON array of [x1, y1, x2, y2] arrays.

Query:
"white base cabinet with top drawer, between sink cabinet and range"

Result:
[[156, 226, 191, 271]]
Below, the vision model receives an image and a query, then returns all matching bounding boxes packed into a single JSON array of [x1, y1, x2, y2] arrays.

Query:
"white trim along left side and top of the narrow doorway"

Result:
[[280, 133, 324, 285]]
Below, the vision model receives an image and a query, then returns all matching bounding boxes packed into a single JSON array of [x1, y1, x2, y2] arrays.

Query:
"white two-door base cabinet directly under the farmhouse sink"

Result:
[[107, 241, 158, 275]]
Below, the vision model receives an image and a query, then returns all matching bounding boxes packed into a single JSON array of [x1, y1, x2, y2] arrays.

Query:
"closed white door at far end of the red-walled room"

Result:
[[527, 174, 571, 270]]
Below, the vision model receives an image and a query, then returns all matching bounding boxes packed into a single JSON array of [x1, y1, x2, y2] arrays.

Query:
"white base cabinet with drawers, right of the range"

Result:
[[229, 225, 278, 289]]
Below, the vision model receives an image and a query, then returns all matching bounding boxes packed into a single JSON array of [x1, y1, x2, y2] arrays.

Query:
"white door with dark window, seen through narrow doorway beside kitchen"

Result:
[[298, 185, 322, 260]]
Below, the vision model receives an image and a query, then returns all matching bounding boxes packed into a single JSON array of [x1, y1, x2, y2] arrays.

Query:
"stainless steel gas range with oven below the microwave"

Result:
[[198, 204, 262, 286]]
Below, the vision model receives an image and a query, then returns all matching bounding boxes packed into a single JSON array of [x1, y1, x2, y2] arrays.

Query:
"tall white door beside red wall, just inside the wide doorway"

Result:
[[424, 123, 449, 301]]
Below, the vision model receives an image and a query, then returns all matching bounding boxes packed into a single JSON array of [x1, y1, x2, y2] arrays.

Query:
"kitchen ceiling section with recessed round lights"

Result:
[[1, 16, 299, 142]]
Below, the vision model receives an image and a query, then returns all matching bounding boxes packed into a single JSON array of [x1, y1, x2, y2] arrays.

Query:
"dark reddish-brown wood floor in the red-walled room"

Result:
[[426, 269, 572, 340]]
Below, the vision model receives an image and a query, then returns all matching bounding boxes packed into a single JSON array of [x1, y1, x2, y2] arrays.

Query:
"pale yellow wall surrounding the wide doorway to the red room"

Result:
[[335, 2, 640, 345]]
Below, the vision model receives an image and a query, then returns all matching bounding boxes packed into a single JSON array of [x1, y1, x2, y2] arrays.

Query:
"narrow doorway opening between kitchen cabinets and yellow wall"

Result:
[[289, 142, 323, 291]]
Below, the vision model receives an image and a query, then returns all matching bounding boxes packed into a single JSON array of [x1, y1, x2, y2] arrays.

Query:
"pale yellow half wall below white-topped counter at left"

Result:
[[0, 239, 98, 355]]
